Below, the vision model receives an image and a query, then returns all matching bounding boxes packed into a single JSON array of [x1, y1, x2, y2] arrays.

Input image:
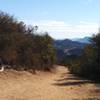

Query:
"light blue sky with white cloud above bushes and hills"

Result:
[[0, 0, 100, 39]]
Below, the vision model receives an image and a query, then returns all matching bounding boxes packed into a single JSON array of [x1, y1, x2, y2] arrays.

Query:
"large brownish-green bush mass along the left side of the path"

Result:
[[0, 12, 55, 70]]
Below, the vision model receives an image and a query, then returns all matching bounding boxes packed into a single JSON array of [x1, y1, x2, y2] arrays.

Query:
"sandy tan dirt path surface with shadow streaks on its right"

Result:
[[0, 66, 100, 100]]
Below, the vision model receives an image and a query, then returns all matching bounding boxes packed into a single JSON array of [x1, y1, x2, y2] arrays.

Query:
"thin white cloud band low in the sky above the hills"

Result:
[[24, 20, 99, 39]]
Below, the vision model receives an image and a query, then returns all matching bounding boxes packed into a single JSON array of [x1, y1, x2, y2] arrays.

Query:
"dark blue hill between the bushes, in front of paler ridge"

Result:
[[54, 39, 87, 59]]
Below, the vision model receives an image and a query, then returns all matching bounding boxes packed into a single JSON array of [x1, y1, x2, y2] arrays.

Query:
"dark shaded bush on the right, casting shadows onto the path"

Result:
[[69, 34, 100, 81]]
